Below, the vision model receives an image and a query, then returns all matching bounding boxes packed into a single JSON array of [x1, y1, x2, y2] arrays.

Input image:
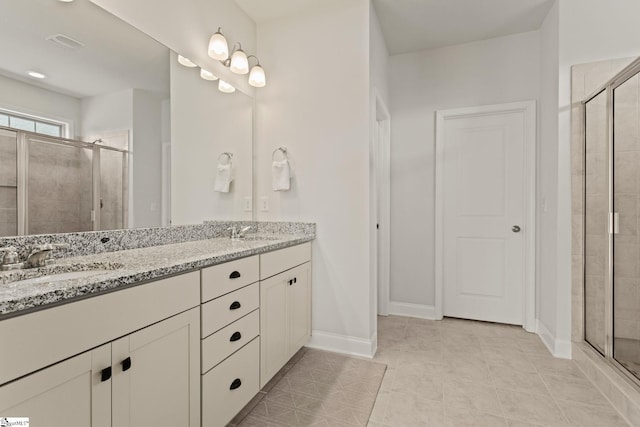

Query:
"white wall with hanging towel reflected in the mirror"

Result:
[[171, 53, 253, 225]]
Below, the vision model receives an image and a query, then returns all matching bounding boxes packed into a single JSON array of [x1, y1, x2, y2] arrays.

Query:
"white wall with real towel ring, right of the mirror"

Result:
[[256, 0, 374, 354]]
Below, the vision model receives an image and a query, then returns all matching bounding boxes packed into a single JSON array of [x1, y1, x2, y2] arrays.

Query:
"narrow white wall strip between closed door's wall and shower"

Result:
[[536, 3, 559, 350]]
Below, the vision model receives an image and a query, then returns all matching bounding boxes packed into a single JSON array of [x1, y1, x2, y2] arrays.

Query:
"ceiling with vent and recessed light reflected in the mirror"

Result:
[[0, 0, 169, 98]]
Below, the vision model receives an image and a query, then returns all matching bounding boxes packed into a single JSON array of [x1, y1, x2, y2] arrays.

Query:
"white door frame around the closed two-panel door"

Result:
[[435, 101, 537, 332]]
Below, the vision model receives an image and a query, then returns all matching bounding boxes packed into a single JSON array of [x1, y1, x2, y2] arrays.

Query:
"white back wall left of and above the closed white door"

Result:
[[390, 31, 540, 313]]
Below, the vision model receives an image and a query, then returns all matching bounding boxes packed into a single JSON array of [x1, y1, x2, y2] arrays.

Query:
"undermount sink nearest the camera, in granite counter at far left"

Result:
[[2, 263, 122, 285]]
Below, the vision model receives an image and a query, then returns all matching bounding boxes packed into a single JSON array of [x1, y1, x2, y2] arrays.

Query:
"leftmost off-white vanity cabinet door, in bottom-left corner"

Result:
[[0, 344, 111, 427]]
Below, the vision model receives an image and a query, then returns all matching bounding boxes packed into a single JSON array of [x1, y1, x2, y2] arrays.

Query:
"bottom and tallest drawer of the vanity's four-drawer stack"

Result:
[[202, 337, 260, 427]]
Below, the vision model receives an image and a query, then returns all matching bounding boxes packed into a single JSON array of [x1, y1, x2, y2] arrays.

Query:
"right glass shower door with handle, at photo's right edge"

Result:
[[612, 74, 640, 377]]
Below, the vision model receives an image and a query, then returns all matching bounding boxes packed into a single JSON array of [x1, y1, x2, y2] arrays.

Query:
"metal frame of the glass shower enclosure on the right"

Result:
[[580, 58, 640, 386]]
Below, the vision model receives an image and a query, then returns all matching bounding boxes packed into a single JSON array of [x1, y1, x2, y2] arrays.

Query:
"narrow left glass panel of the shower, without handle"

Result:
[[584, 91, 609, 354]]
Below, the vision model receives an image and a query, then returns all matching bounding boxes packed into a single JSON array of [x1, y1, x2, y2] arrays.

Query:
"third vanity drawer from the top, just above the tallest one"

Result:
[[202, 310, 260, 374]]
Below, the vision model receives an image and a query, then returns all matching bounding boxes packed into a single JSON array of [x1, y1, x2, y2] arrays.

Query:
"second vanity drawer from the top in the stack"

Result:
[[201, 283, 260, 338]]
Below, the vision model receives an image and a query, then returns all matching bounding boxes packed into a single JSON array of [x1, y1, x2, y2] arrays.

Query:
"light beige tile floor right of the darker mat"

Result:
[[368, 316, 628, 427]]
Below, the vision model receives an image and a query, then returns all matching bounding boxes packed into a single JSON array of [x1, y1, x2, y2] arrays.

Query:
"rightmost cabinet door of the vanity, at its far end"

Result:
[[287, 262, 311, 360]]
